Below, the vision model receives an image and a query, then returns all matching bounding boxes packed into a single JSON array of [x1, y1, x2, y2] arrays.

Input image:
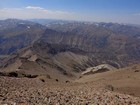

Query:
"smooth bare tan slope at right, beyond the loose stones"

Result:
[[76, 64, 140, 97]]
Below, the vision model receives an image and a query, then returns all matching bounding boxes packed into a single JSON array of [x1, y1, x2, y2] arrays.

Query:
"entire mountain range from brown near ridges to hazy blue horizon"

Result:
[[0, 19, 140, 80]]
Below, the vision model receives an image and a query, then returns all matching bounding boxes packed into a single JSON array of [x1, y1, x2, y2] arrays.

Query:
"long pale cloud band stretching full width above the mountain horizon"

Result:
[[0, 6, 140, 24]]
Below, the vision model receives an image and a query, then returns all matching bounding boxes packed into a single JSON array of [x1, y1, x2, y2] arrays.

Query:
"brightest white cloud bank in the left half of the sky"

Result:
[[0, 6, 76, 19]]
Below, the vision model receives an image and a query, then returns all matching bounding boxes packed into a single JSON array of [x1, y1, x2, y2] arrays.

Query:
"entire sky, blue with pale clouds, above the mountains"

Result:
[[0, 0, 140, 24]]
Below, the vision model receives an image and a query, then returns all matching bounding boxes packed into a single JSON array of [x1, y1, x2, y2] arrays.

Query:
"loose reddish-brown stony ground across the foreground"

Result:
[[0, 77, 140, 105]]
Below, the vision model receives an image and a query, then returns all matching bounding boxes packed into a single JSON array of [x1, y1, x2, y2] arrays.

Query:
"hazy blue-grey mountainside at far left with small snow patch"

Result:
[[0, 19, 45, 55]]
